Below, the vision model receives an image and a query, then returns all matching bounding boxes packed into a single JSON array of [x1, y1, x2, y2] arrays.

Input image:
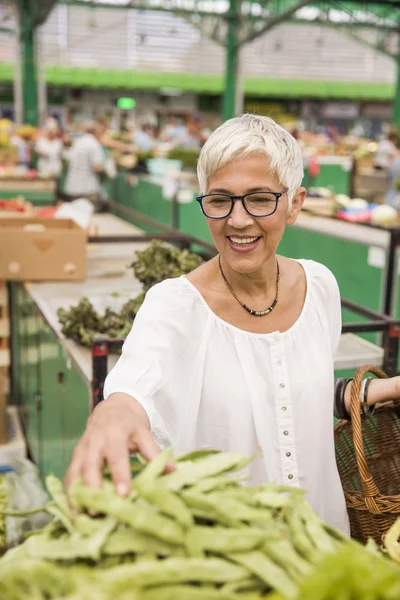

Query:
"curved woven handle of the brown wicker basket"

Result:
[[350, 365, 388, 502]]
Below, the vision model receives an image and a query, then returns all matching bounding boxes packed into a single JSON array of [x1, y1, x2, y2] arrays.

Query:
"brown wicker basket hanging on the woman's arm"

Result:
[[335, 366, 400, 544]]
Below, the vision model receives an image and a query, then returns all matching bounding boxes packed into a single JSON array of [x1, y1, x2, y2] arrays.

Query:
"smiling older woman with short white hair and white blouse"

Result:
[[67, 114, 399, 531]]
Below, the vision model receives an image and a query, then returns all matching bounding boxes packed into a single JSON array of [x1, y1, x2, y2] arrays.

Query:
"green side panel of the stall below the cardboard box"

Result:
[[12, 284, 90, 477]]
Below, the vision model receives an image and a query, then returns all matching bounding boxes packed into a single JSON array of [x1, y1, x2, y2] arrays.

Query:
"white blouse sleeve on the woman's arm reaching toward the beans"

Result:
[[104, 280, 188, 447]]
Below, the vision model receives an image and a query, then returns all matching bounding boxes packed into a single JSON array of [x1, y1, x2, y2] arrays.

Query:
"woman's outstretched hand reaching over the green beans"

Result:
[[66, 393, 160, 495]]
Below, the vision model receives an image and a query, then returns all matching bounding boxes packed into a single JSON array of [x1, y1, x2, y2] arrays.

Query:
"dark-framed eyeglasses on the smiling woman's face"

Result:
[[196, 188, 289, 219]]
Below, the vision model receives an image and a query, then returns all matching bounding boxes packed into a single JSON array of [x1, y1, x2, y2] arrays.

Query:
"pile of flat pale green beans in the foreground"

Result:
[[0, 450, 384, 600]]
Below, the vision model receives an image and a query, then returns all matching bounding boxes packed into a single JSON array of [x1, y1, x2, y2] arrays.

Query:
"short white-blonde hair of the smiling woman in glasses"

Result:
[[197, 114, 304, 208]]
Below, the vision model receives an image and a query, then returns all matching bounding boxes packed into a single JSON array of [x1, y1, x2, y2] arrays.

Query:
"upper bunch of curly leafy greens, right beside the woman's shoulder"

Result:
[[130, 240, 203, 292]]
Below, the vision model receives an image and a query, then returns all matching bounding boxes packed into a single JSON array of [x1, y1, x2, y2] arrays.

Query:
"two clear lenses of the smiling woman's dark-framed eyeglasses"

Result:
[[203, 192, 277, 217]]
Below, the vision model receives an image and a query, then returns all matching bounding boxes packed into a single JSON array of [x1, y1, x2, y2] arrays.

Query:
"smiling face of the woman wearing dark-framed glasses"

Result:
[[207, 153, 306, 274]]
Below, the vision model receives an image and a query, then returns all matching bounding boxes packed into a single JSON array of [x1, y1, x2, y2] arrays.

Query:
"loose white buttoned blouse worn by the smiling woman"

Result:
[[104, 260, 349, 532]]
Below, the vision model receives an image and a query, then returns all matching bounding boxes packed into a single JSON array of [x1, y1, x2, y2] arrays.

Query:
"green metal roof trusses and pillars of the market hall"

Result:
[[5, 0, 400, 122]]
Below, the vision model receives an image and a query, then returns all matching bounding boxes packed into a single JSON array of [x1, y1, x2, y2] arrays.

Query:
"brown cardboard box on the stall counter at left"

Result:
[[0, 215, 86, 281]]
